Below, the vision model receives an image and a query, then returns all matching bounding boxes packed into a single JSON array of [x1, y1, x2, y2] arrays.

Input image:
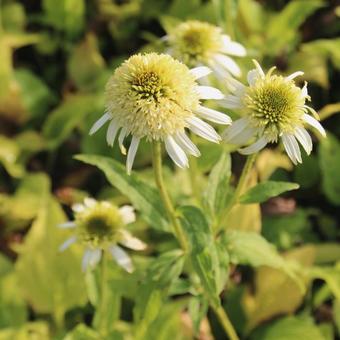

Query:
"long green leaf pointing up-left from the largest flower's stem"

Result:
[[75, 155, 169, 231]]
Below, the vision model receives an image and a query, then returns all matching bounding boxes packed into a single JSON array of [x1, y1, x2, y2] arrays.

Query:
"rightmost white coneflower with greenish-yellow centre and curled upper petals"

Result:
[[223, 61, 326, 164]]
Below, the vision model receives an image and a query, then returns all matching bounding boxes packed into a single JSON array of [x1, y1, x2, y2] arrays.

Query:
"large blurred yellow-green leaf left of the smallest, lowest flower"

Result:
[[15, 177, 86, 317]]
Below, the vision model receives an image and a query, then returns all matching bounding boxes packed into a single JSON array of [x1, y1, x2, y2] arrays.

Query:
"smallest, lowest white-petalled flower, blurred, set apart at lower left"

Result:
[[59, 198, 146, 272]]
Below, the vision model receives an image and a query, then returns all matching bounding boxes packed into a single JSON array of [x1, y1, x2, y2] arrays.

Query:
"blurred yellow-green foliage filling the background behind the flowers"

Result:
[[0, 0, 340, 340]]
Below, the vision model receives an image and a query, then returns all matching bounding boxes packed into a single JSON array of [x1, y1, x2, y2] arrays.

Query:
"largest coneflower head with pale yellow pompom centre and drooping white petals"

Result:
[[90, 53, 231, 173]]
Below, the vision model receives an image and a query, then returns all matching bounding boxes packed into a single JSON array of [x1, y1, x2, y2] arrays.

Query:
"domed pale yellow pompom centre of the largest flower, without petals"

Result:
[[106, 53, 199, 140]]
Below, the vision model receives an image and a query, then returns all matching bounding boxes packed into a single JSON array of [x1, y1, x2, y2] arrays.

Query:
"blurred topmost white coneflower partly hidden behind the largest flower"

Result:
[[163, 20, 246, 80]]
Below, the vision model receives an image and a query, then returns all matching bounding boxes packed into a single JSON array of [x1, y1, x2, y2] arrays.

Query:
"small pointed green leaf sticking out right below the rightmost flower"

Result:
[[239, 181, 299, 204]]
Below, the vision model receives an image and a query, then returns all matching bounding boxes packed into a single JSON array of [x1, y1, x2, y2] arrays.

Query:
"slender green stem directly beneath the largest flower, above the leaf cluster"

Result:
[[152, 142, 188, 252]]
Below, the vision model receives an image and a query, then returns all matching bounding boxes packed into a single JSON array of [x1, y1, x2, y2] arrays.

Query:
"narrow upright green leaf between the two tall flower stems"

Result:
[[203, 153, 231, 216]]
